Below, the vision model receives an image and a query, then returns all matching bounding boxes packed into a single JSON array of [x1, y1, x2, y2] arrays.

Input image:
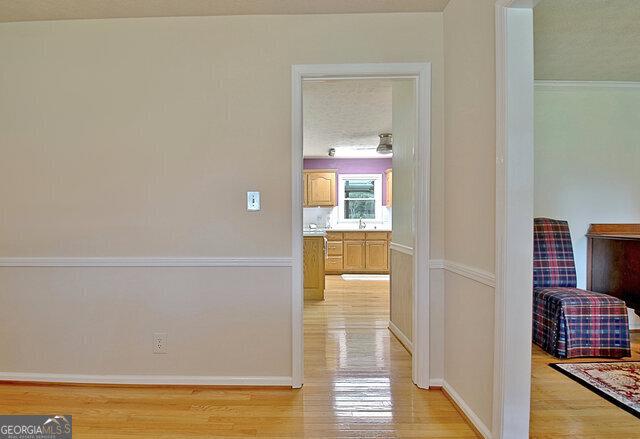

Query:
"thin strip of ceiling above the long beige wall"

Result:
[[0, 0, 449, 22]]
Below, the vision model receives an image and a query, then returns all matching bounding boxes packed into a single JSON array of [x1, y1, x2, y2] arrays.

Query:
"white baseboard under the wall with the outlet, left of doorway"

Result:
[[0, 372, 291, 386]]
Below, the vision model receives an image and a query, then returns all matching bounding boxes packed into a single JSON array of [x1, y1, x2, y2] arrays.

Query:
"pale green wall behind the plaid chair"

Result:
[[535, 85, 640, 326]]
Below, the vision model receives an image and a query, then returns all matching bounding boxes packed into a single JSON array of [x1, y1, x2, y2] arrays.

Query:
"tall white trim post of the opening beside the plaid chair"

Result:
[[492, 0, 538, 439]]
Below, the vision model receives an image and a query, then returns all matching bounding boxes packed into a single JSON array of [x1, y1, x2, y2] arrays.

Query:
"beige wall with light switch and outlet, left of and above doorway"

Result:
[[0, 13, 444, 384]]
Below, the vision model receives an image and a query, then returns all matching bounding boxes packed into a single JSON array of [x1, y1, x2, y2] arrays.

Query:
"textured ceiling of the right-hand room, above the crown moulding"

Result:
[[534, 0, 640, 81]]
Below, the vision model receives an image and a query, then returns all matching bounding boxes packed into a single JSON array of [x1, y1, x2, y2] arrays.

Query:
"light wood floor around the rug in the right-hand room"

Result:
[[530, 333, 640, 439]]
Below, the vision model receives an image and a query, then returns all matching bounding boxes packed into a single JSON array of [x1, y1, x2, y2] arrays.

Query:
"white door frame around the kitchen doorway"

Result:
[[291, 63, 431, 389]]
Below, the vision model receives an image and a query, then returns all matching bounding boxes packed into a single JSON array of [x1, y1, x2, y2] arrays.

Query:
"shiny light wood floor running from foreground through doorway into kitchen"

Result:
[[0, 276, 476, 439]]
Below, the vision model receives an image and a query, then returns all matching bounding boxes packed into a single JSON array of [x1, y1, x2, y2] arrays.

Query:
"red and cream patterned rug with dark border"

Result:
[[549, 361, 640, 418]]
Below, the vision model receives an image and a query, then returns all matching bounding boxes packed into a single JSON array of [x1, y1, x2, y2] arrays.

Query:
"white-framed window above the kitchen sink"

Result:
[[338, 174, 382, 222]]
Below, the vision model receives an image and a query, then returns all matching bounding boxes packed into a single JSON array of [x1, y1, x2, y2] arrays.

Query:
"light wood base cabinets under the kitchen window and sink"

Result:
[[325, 231, 391, 274]]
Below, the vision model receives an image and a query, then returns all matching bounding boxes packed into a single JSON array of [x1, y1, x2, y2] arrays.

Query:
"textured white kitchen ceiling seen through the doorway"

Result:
[[302, 79, 393, 157]]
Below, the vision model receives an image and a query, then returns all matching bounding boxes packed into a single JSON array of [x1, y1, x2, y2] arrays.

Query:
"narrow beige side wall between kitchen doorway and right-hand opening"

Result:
[[444, 0, 496, 431]]
